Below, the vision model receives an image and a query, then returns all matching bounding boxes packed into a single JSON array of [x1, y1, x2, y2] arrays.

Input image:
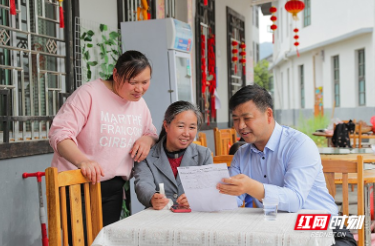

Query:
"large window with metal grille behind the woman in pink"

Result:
[[0, 0, 77, 159]]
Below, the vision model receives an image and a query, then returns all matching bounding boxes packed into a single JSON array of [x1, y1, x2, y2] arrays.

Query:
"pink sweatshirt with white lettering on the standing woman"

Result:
[[49, 79, 157, 181]]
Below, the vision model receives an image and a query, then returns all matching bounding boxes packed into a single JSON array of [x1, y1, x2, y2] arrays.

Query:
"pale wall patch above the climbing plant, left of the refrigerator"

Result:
[[79, 0, 118, 29]]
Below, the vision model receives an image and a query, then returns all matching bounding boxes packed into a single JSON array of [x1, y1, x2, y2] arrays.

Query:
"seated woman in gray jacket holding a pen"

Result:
[[134, 101, 213, 210]]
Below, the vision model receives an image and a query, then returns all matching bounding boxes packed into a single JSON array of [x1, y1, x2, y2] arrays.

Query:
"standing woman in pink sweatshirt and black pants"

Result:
[[49, 51, 157, 226]]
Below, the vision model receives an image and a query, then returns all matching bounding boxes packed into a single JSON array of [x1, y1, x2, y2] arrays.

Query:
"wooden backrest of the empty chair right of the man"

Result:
[[322, 155, 364, 245]]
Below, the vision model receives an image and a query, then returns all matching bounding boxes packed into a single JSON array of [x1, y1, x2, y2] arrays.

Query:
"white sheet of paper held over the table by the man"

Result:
[[177, 163, 237, 211]]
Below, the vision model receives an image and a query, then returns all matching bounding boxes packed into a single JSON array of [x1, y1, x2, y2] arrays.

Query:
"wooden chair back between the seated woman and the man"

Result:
[[214, 127, 237, 155]]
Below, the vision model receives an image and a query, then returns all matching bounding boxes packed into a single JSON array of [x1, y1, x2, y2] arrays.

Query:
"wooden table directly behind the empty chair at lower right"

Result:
[[320, 152, 375, 246]]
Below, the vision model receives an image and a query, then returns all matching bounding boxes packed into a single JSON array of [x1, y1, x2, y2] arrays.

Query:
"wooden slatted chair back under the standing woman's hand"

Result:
[[45, 167, 103, 246]]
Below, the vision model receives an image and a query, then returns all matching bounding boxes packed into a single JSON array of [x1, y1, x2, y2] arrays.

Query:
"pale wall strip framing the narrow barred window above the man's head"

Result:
[[215, 0, 253, 123]]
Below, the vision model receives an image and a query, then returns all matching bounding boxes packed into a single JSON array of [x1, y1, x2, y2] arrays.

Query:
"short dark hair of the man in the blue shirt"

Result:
[[229, 84, 273, 112]]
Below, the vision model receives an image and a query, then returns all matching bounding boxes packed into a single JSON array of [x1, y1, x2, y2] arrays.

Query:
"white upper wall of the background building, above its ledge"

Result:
[[274, 0, 375, 61]]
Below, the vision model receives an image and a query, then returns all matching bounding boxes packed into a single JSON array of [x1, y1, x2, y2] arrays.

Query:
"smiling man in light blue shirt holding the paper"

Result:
[[218, 85, 356, 245]]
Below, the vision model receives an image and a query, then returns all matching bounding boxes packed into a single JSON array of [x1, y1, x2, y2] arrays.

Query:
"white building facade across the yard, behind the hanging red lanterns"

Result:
[[270, 0, 375, 126]]
